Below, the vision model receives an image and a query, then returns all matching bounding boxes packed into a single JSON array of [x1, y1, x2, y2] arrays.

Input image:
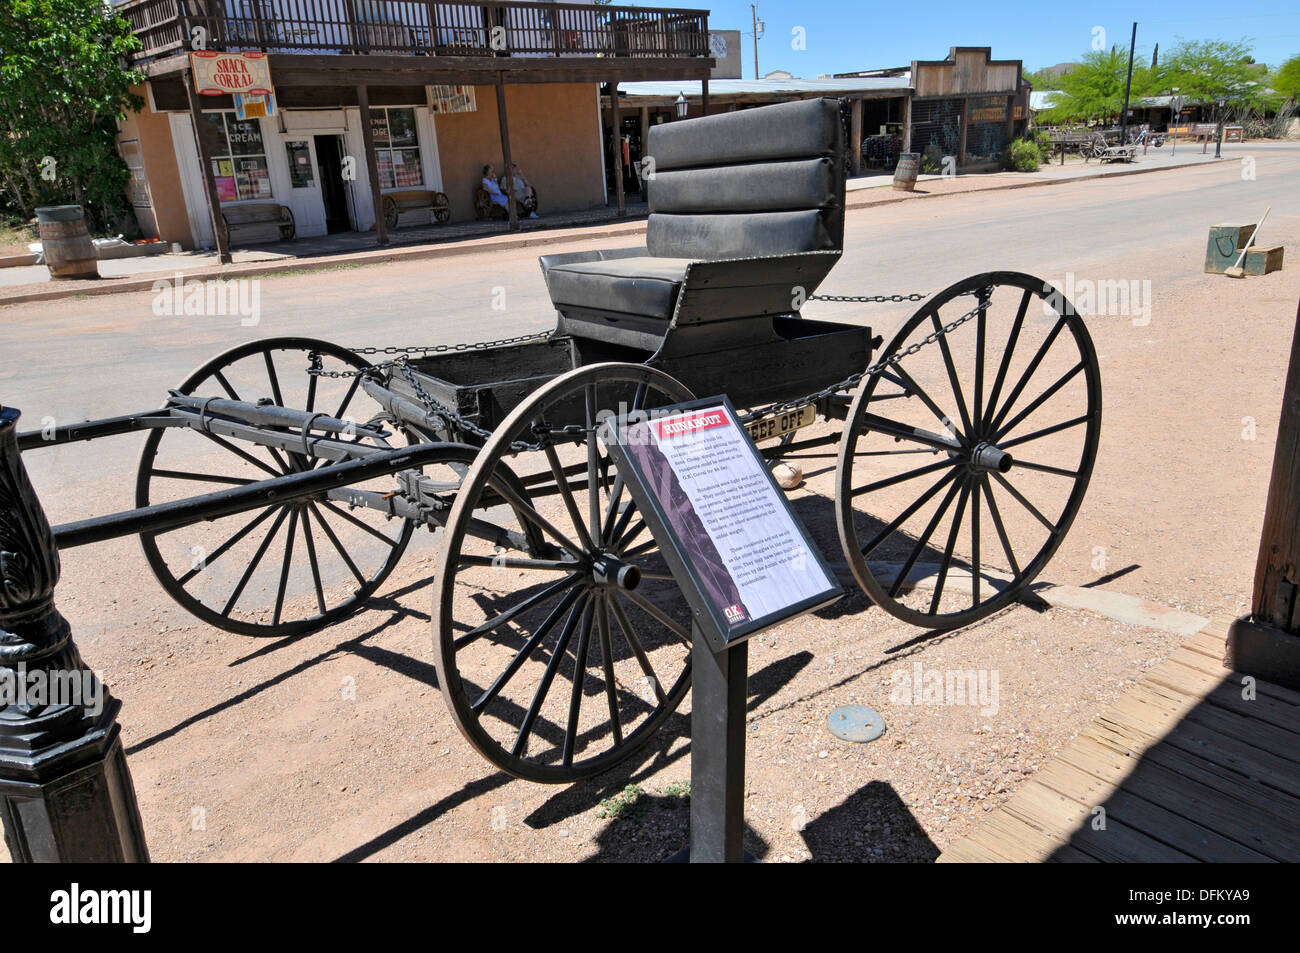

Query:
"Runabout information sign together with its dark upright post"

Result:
[[603, 397, 844, 863]]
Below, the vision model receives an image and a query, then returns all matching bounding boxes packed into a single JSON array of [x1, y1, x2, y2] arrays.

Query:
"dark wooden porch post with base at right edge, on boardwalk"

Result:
[[1226, 297, 1300, 689]]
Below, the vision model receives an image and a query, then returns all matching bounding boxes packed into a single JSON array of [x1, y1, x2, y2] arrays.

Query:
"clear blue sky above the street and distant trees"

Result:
[[707, 0, 1300, 78]]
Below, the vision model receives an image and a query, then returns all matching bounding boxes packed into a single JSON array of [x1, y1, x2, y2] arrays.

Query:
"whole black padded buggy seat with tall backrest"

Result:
[[541, 99, 844, 350]]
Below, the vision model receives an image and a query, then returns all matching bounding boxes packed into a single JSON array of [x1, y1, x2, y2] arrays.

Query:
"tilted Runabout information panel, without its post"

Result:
[[606, 397, 844, 651]]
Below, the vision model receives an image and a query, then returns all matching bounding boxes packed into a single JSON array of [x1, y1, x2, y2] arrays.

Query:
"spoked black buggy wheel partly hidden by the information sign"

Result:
[[433, 364, 692, 783]]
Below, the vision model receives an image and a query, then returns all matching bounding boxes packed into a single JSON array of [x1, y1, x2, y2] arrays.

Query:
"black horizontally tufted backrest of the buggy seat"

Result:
[[646, 99, 844, 260]]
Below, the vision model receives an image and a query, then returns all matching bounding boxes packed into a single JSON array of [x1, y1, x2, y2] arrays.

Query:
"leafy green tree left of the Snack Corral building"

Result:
[[0, 0, 143, 229]]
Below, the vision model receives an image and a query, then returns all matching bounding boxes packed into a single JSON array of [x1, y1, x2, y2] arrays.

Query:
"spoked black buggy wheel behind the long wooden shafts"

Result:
[[135, 338, 416, 636]]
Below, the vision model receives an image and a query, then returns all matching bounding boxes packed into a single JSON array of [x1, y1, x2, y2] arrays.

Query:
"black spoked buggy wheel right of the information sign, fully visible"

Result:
[[836, 272, 1101, 629]]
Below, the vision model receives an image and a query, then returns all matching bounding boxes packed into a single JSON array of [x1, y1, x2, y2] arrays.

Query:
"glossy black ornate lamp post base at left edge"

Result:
[[0, 407, 148, 862]]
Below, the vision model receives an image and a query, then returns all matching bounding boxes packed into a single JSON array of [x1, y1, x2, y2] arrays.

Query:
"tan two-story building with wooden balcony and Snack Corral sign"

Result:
[[117, 0, 714, 256]]
